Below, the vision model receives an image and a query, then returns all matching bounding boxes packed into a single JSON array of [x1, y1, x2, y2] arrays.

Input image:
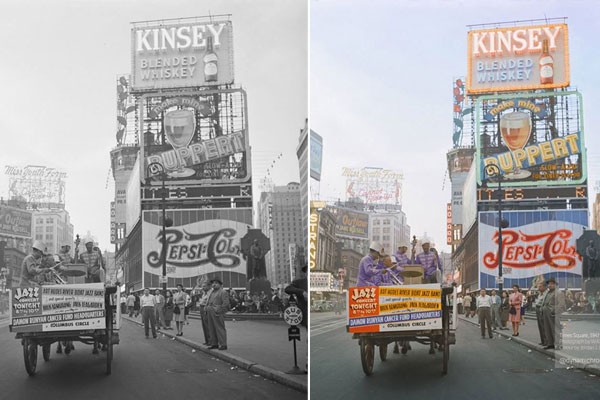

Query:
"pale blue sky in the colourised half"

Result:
[[310, 0, 600, 251]]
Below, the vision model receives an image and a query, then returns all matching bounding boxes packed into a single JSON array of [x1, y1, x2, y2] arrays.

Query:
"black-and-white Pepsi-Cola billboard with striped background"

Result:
[[142, 209, 252, 288]]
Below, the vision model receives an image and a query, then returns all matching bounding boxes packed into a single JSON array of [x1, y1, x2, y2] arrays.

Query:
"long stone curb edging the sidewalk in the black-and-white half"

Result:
[[123, 318, 308, 393]]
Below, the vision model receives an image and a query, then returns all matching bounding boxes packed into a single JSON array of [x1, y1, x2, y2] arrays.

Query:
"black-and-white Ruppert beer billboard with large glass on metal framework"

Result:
[[138, 89, 251, 186]]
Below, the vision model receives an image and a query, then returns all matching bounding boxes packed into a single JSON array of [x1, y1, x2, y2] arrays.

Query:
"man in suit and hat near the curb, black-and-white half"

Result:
[[205, 279, 229, 350]]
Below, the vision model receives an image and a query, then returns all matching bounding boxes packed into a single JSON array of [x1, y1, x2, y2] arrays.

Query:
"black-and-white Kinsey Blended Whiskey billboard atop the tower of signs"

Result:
[[131, 18, 233, 91]]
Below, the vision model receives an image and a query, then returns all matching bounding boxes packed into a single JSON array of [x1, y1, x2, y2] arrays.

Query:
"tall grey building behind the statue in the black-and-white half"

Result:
[[258, 182, 306, 287]]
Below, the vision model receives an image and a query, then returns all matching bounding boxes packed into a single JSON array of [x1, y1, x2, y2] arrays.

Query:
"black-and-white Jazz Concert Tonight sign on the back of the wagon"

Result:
[[10, 283, 106, 332]]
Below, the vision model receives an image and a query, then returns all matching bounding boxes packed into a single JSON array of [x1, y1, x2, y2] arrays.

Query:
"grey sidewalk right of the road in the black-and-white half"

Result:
[[123, 315, 308, 392]]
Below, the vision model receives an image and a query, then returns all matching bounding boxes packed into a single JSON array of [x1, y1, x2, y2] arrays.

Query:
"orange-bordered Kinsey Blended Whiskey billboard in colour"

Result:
[[467, 24, 570, 95]]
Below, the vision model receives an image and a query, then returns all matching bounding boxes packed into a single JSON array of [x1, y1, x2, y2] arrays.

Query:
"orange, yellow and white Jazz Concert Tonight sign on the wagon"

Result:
[[347, 284, 442, 333]]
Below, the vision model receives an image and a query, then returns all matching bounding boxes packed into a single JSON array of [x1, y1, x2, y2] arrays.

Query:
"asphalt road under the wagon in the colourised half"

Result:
[[310, 313, 600, 400]]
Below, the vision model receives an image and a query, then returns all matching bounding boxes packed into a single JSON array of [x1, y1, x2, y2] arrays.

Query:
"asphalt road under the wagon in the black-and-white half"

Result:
[[0, 320, 307, 400]]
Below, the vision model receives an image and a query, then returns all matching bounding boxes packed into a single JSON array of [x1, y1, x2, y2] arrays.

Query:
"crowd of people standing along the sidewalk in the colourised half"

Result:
[[457, 278, 584, 349]]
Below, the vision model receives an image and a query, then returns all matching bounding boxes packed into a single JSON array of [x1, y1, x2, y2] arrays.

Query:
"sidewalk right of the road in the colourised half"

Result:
[[458, 314, 600, 376]]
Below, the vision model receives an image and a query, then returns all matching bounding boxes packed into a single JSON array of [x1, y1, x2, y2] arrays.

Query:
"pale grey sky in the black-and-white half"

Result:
[[0, 0, 308, 250]]
